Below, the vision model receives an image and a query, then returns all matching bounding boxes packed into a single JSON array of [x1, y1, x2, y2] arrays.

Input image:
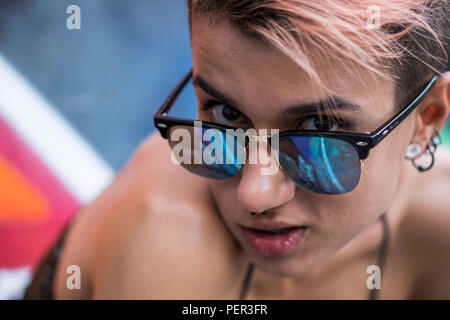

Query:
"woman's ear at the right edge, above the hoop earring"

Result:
[[411, 71, 450, 150]]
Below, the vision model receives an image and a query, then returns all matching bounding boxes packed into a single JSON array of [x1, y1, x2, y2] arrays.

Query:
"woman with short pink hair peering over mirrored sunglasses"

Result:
[[28, 0, 450, 299]]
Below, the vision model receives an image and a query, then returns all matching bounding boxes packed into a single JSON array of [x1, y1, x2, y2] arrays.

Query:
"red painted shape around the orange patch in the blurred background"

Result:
[[0, 117, 80, 268]]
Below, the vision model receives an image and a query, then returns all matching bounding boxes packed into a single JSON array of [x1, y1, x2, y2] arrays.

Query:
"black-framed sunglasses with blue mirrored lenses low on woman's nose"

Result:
[[154, 70, 439, 194]]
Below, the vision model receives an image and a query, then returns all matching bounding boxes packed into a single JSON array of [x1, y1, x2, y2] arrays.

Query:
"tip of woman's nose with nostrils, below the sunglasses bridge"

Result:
[[237, 152, 296, 212]]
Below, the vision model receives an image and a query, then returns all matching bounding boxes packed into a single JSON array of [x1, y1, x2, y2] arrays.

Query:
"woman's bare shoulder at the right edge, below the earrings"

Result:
[[399, 147, 450, 299]]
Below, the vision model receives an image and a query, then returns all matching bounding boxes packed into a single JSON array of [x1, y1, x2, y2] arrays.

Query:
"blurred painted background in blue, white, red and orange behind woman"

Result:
[[0, 0, 450, 299]]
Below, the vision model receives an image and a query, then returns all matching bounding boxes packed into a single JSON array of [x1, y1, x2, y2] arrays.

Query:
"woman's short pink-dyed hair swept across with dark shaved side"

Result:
[[188, 0, 450, 104]]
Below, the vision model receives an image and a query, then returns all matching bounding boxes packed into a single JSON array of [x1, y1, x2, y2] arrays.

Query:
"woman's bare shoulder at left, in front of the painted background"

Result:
[[55, 134, 248, 299]]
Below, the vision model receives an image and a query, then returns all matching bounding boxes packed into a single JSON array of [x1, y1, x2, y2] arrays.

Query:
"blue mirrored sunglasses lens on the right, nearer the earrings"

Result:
[[279, 137, 361, 194]]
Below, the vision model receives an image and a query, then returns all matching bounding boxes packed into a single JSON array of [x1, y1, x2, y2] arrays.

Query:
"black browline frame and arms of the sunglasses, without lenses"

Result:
[[153, 70, 439, 160]]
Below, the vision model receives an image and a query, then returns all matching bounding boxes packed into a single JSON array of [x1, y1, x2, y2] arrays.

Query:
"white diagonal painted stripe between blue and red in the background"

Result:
[[0, 54, 114, 203]]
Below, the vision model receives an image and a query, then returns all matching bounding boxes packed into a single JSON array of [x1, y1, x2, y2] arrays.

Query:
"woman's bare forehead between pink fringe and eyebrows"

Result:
[[191, 18, 394, 126]]
